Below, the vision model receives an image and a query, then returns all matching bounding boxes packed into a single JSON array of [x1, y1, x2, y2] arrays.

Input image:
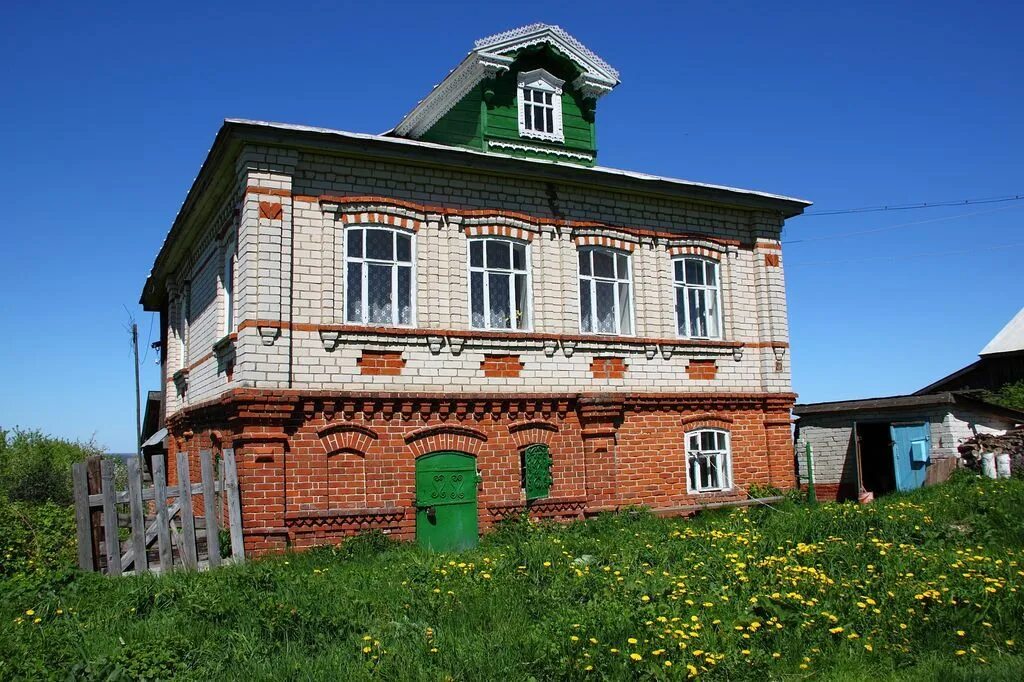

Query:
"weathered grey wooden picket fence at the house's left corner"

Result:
[[72, 449, 245, 576]]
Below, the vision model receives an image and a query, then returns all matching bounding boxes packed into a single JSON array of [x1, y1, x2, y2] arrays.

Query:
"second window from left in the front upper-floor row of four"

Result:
[[469, 239, 529, 330]]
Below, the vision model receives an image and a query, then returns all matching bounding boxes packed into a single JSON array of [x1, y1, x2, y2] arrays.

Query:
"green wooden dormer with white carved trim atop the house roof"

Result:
[[391, 24, 618, 166]]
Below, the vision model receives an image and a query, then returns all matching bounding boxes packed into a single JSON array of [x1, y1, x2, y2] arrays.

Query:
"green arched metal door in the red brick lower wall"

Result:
[[416, 453, 477, 552]]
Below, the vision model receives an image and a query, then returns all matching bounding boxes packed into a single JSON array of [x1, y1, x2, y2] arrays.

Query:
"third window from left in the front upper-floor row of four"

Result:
[[580, 247, 633, 335]]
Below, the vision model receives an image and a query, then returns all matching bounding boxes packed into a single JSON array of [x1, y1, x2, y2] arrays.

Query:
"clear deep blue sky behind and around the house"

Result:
[[0, 0, 1024, 452]]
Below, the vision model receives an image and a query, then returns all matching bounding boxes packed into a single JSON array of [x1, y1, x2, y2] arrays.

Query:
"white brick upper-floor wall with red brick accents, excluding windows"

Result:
[[165, 146, 791, 413]]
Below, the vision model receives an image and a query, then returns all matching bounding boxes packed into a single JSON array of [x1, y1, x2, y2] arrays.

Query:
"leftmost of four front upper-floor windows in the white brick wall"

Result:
[[345, 227, 414, 326]]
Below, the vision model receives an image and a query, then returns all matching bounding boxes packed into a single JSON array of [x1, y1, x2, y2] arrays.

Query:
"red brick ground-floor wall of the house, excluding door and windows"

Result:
[[168, 389, 796, 554]]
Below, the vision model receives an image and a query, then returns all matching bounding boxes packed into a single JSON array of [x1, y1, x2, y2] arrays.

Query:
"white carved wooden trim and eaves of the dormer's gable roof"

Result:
[[394, 24, 618, 139]]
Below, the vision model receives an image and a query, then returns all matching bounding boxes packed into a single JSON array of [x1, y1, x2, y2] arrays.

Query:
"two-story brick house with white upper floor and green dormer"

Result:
[[142, 25, 808, 552]]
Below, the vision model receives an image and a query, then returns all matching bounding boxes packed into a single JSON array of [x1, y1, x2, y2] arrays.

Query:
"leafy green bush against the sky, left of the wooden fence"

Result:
[[0, 428, 103, 505]]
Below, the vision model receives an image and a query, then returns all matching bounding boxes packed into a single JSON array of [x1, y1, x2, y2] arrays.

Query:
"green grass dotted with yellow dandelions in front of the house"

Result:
[[0, 477, 1024, 682]]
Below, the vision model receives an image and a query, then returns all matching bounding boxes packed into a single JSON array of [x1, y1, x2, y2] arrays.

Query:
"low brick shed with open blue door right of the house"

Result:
[[794, 391, 1024, 500]]
